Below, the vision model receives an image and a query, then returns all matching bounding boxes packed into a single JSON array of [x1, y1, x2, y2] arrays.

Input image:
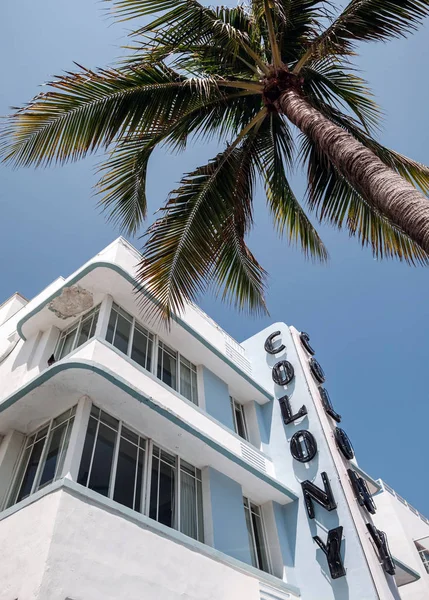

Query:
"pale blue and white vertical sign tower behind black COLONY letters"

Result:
[[242, 323, 398, 600]]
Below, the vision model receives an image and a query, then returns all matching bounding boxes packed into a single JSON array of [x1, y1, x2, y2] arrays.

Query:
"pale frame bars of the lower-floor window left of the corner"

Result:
[[3, 404, 77, 509]]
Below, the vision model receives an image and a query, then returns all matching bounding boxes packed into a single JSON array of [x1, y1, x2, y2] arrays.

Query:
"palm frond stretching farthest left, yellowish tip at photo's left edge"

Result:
[[1, 65, 221, 166]]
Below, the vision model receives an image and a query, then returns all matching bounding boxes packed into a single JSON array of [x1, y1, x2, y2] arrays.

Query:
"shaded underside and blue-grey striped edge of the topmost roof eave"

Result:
[[17, 261, 273, 404]]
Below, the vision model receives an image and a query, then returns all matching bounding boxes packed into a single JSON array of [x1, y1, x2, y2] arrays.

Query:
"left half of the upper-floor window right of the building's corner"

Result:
[[106, 304, 153, 371]]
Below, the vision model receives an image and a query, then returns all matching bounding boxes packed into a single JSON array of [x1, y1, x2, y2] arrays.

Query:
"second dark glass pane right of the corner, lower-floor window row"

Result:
[[88, 423, 117, 496]]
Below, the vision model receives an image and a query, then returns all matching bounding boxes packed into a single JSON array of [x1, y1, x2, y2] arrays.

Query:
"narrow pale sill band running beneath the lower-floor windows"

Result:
[[0, 478, 301, 599]]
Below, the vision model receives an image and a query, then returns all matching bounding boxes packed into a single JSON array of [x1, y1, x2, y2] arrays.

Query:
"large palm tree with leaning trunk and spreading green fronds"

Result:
[[2, 0, 429, 319]]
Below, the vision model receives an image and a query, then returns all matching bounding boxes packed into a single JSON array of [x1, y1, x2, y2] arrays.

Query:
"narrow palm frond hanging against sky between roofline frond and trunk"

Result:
[[254, 114, 328, 262]]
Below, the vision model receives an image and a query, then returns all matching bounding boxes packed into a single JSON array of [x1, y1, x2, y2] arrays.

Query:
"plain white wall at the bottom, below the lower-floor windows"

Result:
[[0, 491, 270, 600]]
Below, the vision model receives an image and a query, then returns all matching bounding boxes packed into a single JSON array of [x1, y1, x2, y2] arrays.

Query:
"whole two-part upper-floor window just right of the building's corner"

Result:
[[106, 304, 198, 405]]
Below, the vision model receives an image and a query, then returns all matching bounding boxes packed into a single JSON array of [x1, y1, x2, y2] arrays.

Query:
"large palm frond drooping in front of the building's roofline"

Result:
[[139, 111, 265, 319]]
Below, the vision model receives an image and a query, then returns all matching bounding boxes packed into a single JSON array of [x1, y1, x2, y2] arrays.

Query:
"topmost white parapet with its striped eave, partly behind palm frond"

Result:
[[17, 239, 272, 404]]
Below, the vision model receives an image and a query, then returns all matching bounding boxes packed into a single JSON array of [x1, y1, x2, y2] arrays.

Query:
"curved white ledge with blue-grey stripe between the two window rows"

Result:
[[0, 352, 297, 504]]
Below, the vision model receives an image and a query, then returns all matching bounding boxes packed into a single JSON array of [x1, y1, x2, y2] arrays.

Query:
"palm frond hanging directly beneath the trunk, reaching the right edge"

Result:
[[300, 135, 429, 265]]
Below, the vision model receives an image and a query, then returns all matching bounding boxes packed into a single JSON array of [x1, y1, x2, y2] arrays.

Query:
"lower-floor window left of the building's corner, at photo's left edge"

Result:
[[7, 407, 76, 506]]
